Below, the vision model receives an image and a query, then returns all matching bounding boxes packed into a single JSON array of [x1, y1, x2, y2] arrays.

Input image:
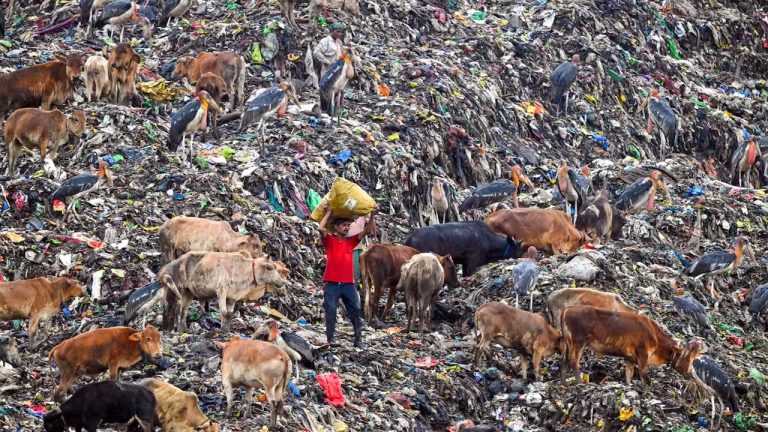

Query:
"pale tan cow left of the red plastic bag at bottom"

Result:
[[214, 336, 293, 428]]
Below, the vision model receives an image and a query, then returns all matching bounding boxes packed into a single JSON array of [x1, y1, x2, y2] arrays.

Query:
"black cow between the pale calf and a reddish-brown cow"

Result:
[[405, 221, 522, 276]]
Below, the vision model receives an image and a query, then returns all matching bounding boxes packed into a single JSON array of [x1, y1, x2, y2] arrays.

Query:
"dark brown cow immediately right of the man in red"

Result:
[[360, 244, 459, 321]]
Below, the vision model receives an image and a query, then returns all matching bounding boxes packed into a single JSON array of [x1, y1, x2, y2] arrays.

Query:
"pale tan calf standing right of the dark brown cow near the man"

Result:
[[397, 253, 453, 337]]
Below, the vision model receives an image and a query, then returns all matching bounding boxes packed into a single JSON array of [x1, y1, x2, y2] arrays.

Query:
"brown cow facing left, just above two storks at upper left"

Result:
[[173, 51, 245, 111]]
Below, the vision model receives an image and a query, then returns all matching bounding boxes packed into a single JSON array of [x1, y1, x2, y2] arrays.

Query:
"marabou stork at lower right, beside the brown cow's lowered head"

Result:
[[691, 356, 739, 430]]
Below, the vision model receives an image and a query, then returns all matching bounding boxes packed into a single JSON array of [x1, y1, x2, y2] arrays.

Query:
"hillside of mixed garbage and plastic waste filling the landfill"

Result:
[[0, 0, 768, 432]]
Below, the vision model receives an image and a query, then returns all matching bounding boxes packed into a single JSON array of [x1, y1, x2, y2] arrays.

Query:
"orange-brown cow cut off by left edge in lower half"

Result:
[[0, 277, 85, 349]]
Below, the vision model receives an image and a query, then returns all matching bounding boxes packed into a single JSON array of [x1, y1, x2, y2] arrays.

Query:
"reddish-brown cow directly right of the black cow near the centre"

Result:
[[485, 207, 588, 255]]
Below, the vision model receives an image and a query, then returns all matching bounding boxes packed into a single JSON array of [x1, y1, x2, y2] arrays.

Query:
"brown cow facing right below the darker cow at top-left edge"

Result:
[[5, 108, 86, 175]]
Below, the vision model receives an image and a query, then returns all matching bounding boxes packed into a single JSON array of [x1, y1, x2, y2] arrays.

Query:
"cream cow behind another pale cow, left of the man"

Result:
[[157, 216, 262, 262]]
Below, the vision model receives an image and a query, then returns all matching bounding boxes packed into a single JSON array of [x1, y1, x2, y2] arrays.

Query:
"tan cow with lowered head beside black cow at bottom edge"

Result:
[[137, 378, 221, 432]]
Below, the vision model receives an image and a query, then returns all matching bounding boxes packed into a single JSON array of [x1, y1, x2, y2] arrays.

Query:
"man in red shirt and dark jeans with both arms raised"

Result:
[[320, 204, 378, 348]]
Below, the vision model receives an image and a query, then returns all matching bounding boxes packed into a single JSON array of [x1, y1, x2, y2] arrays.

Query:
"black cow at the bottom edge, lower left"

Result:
[[43, 381, 155, 432]]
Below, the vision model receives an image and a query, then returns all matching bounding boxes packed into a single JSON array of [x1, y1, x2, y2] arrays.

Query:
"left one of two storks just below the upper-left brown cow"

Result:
[[168, 90, 221, 162]]
